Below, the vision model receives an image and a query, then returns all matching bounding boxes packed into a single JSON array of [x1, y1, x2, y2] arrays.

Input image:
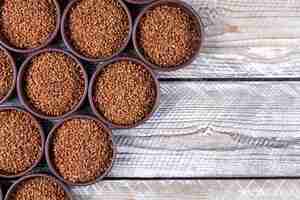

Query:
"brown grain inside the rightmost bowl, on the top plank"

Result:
[[137, 5, 201, 67]]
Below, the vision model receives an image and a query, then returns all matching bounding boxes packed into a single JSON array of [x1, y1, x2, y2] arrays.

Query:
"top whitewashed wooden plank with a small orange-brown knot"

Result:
[[159, 0, 300, 78]]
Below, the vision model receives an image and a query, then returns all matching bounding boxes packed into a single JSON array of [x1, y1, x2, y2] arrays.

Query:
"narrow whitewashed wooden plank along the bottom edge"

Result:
[[73, 179, 300, 200]]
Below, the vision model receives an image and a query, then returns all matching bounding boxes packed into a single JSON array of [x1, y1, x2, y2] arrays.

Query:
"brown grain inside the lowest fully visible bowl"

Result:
[[50, 118, 113, 183]]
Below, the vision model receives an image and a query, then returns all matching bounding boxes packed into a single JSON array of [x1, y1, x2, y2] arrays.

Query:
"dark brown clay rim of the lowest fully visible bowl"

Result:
[[45, 115, 116, 186]]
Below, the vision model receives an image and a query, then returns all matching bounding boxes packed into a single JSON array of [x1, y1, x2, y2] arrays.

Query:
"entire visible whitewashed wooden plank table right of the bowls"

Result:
[[7, 0, 300, 200]]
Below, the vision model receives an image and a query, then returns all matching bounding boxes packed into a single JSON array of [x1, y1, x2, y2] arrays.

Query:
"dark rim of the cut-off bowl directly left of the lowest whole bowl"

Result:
[[0, 106, 46, 179]]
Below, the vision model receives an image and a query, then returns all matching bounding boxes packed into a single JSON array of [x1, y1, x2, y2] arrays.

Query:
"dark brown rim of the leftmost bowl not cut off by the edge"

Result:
[[17, 48, 88, 120]]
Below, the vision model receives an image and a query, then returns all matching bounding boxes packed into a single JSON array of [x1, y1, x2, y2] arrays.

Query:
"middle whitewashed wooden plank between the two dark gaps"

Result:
[[110, 82, 300, 177]]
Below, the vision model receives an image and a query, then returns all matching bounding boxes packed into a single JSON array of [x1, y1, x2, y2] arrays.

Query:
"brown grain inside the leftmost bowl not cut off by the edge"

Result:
[[23, 52, 85, 117]]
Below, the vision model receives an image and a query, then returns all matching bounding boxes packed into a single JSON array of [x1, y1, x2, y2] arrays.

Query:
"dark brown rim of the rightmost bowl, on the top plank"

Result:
[[132, 0, 205, 71]]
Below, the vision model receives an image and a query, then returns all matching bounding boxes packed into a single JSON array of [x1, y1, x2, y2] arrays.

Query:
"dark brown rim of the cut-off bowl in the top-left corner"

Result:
[[0, 0, 61, 54]]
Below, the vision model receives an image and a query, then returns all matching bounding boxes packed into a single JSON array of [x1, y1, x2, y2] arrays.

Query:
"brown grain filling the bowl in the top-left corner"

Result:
[[0, 0, 56, 49]]
